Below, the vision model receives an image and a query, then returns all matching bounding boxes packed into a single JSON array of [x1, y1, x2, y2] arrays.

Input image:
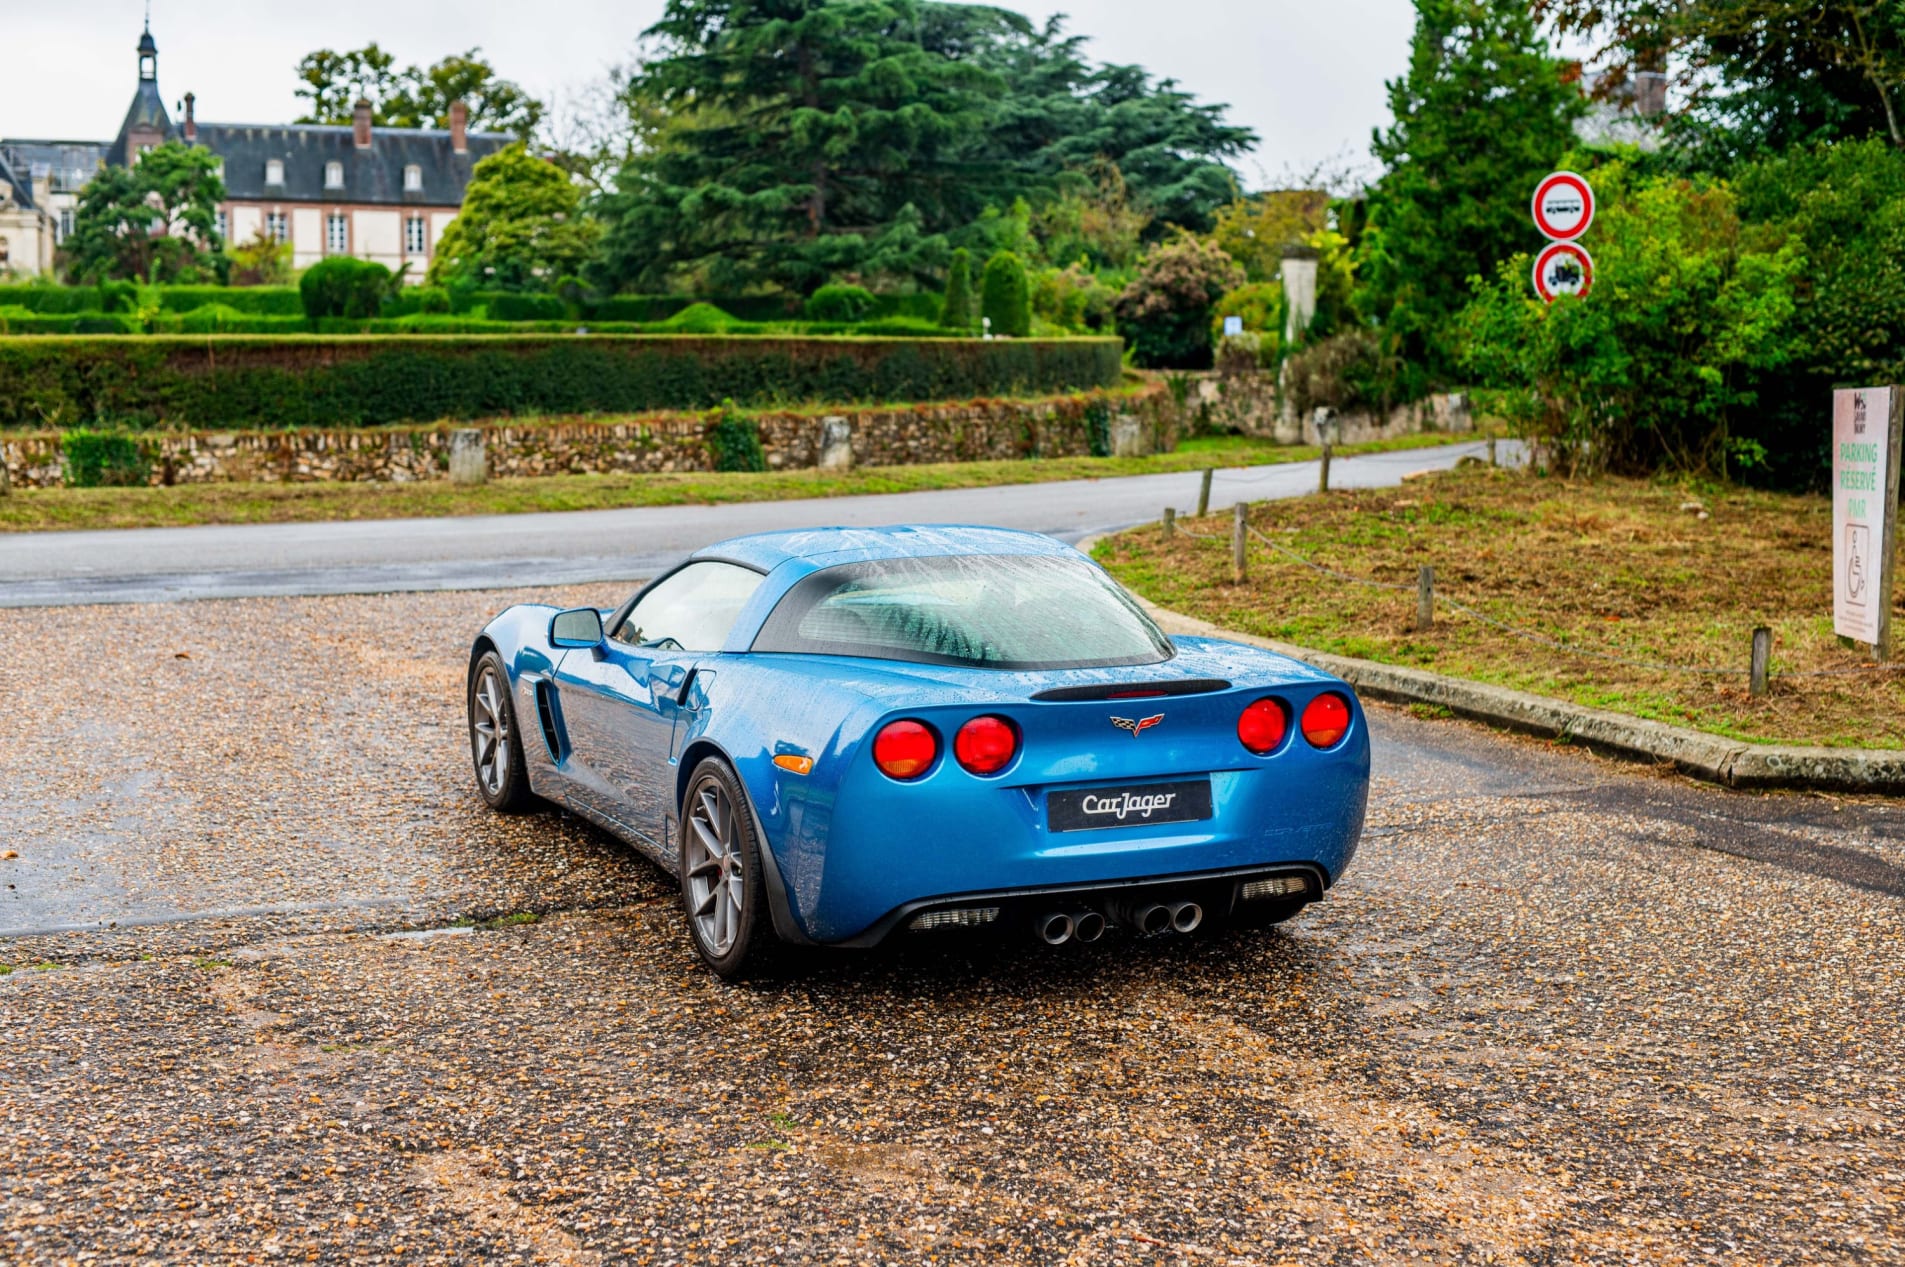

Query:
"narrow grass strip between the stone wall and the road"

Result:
[[0, 426, 1474, 532]]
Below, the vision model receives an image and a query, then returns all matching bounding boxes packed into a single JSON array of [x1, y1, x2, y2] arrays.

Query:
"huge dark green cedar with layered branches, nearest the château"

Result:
[[604, 0, 998, 293]]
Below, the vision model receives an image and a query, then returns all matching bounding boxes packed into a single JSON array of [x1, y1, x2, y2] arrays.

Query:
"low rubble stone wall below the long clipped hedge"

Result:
[[0, 383, 1177, 488]]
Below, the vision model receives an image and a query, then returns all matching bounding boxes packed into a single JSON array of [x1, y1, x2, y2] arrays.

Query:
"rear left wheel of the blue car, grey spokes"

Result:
[[676, 756, 783, 981]]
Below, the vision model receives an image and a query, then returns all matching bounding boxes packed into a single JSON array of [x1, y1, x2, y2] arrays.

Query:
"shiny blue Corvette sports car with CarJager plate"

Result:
[[469, 528, 1370, 977]]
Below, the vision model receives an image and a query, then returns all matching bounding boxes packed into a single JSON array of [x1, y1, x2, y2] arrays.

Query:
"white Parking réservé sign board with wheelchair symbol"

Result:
[[1833, 387, 1905, 661]]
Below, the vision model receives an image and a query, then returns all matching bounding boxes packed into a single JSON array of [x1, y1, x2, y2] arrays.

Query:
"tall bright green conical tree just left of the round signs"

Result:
[[1358, 0, 1585, 377]]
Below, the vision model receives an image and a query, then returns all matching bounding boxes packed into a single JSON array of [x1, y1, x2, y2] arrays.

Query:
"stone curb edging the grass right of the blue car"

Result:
[[1120, 594, 1905, 796]]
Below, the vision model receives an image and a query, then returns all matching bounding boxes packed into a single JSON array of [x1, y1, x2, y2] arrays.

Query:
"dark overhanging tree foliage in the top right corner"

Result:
[[1537, 0, 1905, 158]]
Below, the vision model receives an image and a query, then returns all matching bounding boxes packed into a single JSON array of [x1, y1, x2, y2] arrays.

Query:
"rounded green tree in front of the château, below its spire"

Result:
[[65, 141, 225, 284]]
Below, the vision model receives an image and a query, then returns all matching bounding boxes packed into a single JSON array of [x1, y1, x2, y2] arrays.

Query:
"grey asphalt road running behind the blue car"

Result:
[[0, 444, 1484, 608]]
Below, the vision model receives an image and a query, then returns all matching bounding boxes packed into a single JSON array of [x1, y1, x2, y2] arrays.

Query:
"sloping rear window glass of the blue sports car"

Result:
[[754, 554, 1173, 671]]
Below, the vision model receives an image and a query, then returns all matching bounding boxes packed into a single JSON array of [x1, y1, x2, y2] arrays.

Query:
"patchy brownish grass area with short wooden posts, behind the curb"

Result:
[[1099, 469, 1905, 749]]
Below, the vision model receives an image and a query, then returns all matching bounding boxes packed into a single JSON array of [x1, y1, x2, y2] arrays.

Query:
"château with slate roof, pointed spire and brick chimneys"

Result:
[[0, 27, 514, 280]]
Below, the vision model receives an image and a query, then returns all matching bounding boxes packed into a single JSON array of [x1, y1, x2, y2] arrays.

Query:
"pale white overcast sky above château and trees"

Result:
[[0, 0, 1414, 185]]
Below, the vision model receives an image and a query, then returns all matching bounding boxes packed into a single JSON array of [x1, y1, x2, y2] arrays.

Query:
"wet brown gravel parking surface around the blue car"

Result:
[[0, 591, 1905, 1265]]
